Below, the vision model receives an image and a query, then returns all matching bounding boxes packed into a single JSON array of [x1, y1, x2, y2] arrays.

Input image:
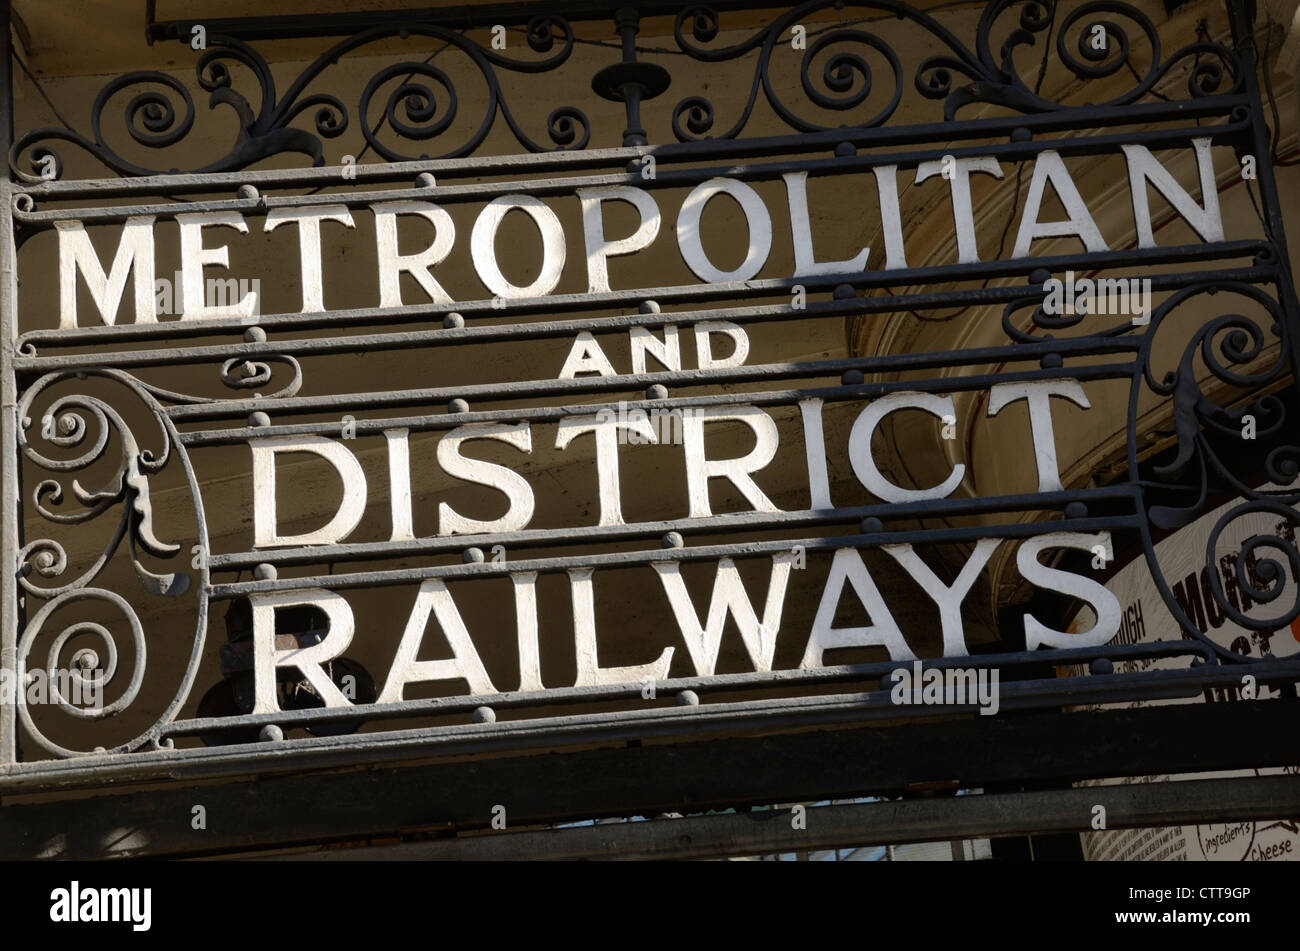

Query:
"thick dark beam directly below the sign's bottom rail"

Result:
[[0, 700, 1300, 859]]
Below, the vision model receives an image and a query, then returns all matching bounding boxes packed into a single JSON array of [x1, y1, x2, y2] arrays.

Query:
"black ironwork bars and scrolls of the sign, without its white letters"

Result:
[[0, 0, 1300, 800]]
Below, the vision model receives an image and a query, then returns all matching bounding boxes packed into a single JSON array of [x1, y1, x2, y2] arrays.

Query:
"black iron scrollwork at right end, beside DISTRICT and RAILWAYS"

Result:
[[1002, 280, 1300, 661]]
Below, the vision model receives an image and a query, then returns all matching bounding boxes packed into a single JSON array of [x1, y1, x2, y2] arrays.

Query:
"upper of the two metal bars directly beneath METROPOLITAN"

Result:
[[20, 239, 1277, 347]]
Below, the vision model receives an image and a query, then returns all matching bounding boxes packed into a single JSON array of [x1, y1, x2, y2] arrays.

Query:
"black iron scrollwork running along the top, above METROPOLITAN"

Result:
[[9, 0, 1243, 182]]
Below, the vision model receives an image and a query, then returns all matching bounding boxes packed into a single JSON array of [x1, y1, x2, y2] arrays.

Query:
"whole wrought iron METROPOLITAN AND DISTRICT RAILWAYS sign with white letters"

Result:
[[0, 0, 1300, 800]]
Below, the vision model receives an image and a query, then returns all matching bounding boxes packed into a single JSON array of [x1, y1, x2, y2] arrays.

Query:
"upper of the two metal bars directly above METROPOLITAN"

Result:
[[14, 95, 1251, 201]]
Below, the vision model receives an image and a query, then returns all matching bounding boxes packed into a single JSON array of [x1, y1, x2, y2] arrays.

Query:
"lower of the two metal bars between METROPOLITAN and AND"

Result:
[[14, 268, 1277, 373]]
